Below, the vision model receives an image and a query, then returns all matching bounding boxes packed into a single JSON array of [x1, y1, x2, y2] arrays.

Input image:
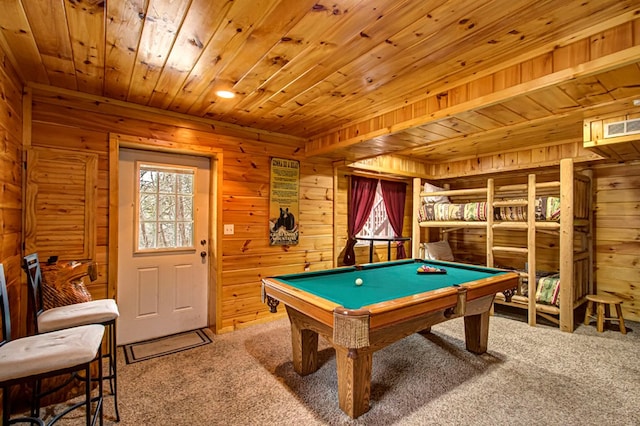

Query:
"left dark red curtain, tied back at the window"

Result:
[[344, 176, 378, 265]]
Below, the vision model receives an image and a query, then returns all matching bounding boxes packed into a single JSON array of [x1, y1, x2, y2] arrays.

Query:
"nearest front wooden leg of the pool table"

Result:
[[335, 346, 373, 418]]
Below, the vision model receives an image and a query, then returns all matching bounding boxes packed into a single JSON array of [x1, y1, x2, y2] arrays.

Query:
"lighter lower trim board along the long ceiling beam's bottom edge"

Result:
[[308, 42, 640, 155]]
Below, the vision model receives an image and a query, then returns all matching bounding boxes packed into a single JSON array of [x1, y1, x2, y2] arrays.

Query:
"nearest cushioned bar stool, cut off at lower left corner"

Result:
[[0, 264, 104, 426]]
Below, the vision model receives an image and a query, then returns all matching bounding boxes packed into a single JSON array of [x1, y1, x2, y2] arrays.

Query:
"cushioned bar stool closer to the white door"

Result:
[[23, 253, 120, 421]]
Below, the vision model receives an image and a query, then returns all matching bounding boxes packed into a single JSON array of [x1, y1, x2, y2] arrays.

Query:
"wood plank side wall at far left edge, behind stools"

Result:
[[0, 43, 26, 336]]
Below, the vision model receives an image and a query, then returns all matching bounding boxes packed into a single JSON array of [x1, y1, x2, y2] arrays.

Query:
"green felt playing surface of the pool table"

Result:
[[277, 259, 507, 309]]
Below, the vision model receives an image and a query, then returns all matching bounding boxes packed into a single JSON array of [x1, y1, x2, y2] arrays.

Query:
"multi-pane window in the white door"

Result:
[[135, 162, 195, 252]]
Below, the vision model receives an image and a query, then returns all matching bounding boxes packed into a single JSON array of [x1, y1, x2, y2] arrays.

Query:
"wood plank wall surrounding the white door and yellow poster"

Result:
[[26, 88, 333, 331]]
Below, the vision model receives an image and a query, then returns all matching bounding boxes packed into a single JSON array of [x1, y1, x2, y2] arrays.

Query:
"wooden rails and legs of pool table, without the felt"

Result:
[[262, 273, 519, 418]]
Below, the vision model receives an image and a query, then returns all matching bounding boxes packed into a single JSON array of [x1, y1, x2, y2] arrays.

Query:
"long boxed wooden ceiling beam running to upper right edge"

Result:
[[306, 13, 640, 156]]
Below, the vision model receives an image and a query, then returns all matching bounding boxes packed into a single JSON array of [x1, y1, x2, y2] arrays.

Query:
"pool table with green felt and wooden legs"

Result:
[[262, 259, 518, 418]]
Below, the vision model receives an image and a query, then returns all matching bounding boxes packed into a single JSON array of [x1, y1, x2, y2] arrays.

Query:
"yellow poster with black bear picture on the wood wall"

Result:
[[269, 158, 300, 246]]
